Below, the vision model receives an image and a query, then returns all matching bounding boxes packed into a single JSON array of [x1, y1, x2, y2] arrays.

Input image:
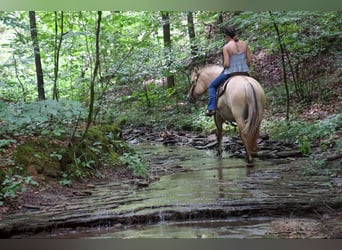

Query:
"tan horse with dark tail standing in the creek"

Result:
[[187, 65, 266, 167]]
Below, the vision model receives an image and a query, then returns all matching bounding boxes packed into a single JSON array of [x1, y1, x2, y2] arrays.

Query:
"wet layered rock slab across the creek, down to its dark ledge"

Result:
[[0, 143, 342, 238]]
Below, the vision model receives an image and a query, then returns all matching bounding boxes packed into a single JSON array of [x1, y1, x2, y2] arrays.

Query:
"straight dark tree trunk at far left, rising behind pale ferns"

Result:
[[29, 11, 45, 101]]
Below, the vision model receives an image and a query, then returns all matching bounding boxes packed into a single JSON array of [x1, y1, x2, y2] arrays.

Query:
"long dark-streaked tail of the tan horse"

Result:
[[243, 81, 262, 147]]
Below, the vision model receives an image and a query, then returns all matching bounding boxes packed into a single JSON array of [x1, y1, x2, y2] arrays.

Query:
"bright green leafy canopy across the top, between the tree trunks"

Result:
[[0, 11, 342, 107]]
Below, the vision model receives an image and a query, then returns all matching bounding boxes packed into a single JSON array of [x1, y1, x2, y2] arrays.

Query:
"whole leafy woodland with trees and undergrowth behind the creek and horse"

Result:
[[0, 11, 342, 205]]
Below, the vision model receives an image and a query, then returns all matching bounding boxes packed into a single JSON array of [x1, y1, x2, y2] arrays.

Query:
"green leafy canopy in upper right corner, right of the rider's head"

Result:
[[230, 11, 342, 55]]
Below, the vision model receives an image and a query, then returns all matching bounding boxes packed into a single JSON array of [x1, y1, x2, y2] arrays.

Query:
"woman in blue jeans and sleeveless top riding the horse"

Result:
[[205, 26, 251, 116]]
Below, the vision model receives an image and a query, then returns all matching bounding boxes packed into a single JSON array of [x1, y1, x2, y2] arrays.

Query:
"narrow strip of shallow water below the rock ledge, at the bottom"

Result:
[[75, 217, 272, 239]]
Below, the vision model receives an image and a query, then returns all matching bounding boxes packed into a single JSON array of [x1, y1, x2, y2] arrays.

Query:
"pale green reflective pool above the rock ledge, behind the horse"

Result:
[[121, 145, 260, 209]]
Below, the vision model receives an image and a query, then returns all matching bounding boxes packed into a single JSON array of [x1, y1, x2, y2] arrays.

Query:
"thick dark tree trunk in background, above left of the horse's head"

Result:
[[161, 12, 175, 88]]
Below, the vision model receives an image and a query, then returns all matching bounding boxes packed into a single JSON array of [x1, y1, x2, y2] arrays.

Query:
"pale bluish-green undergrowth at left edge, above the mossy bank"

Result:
[[0, 100, 86, 137]]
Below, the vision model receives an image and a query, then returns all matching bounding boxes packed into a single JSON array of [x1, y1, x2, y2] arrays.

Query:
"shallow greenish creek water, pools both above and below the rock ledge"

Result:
[[35, 144, 276, 238]]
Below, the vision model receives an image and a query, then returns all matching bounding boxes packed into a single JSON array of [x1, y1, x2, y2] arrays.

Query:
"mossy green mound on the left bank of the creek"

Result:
[[13, 124, 132, 182]]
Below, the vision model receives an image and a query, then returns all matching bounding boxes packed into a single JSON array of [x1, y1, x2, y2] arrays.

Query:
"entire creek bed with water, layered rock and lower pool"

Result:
[[0, 143, 342, 238]]
